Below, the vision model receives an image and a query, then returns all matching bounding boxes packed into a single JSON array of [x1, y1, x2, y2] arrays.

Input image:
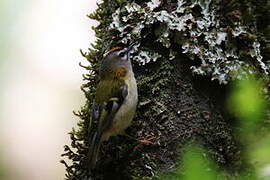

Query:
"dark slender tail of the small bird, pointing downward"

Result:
[[87, 132, 101, 170]]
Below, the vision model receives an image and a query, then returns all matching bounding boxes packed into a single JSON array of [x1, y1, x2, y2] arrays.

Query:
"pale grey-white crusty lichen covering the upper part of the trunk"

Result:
[[109, 0, 269, 84]]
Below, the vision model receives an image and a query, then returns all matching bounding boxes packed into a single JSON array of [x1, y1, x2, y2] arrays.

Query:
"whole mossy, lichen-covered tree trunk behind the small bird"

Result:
[[62, 0, 270, 180]]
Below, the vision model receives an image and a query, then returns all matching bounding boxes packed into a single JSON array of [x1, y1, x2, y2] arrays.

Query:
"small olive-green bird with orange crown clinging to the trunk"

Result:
[[88, 45, 138, 170]]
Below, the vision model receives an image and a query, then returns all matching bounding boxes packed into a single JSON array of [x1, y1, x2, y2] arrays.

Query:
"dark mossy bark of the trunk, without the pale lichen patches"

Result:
[[62, 0, 270, 180]]
